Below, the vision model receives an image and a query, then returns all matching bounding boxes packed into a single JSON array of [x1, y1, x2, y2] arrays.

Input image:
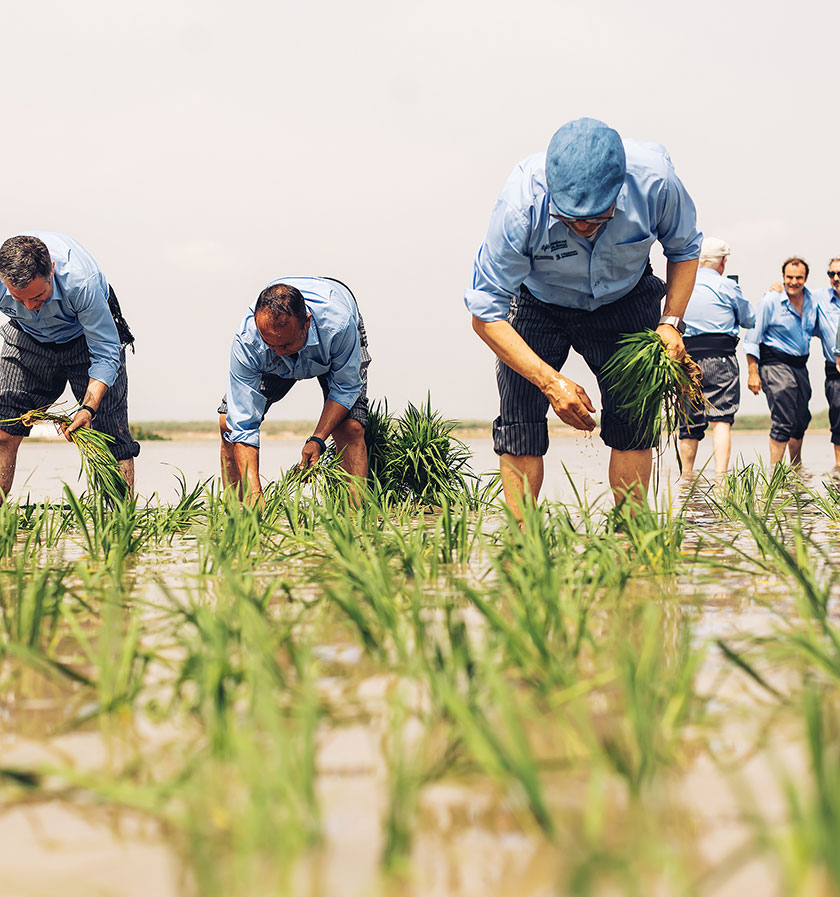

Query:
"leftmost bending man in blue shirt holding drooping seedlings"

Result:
[[0, 231, 140, 501]]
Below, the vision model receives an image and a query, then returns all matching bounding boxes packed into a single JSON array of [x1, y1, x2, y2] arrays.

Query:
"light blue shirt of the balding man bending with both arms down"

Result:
[[225, 277, 362, 448]]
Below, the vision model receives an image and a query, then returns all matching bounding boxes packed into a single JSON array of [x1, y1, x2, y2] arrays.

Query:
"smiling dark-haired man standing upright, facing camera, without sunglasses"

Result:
[[744, 256, 817, 464]]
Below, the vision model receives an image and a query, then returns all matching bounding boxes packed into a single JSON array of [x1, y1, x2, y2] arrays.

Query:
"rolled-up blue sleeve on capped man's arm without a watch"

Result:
[[464, 200, 531, 321]]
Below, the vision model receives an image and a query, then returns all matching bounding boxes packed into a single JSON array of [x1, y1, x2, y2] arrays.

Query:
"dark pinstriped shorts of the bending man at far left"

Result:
[[0, 324, 140, 461]]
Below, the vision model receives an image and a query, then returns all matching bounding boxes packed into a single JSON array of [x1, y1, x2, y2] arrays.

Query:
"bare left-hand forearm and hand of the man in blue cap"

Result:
[[473, 317, 595, 430]]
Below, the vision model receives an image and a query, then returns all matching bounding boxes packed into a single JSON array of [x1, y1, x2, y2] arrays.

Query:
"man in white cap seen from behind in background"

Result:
[[680, 237, 755, 475]]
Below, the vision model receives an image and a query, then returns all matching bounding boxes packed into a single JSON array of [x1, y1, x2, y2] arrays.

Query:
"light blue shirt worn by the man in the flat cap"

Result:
[[464, 140, 702, 321]]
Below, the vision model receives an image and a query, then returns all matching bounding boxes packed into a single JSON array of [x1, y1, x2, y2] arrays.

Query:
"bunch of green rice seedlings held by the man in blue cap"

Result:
[[602, 330, 706, 441]]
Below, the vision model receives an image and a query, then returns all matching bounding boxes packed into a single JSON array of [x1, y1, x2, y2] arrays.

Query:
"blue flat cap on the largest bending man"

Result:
[[545, 118, 627, 218]]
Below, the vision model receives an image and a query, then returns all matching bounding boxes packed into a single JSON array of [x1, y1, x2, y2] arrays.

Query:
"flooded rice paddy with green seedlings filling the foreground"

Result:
[[0, 433, 840, 897]]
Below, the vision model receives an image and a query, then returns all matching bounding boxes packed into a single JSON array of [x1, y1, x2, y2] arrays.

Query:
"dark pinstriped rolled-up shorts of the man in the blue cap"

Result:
[[493, 268, 665, 455]]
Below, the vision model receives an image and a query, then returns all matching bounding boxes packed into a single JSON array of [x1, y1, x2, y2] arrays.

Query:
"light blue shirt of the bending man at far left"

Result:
[[0, 230, 120, 386]]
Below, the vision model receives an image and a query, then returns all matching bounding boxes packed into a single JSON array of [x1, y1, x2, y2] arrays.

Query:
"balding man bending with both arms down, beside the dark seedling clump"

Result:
[[219, 277, 370, 501]]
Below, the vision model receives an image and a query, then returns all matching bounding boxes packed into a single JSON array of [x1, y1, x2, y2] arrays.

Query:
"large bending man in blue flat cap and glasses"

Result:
[[465, 118, 701, 509]]
